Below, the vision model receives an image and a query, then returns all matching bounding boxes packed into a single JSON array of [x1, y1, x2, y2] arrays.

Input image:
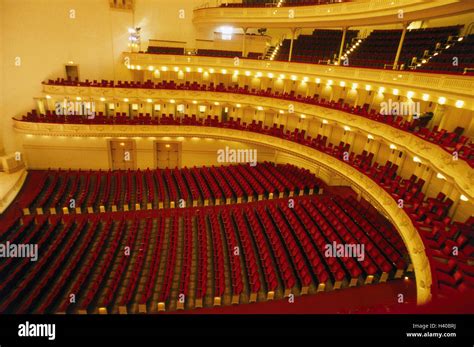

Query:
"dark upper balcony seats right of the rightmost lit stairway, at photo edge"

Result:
[[417, 34, 474, 74]]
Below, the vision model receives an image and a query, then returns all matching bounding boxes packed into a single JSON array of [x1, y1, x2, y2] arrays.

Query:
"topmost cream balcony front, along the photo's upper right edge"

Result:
[[193, 0, 474, 28]]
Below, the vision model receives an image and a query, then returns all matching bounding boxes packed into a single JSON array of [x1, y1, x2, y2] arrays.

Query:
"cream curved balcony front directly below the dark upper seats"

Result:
[[123, 52, 474, 103]]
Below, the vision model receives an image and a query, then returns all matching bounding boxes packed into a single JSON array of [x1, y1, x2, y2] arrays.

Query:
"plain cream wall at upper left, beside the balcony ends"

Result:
[[0, 0, 206, 152]]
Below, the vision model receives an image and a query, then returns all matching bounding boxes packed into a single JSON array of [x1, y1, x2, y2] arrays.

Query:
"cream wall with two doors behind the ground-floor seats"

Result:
[[21, 135, 275, 170]]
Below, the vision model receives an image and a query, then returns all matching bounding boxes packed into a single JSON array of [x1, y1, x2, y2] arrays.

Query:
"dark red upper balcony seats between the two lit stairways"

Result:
[[348, 26, 461, 69]]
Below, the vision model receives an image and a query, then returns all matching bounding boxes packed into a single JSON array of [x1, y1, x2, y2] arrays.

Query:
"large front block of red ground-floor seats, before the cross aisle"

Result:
[[0, 193, 414, 313]]
